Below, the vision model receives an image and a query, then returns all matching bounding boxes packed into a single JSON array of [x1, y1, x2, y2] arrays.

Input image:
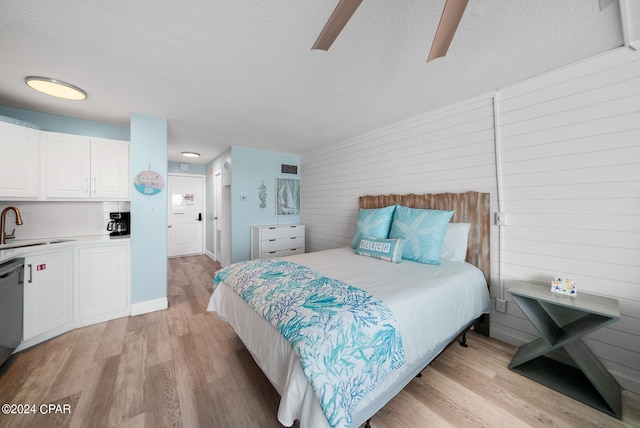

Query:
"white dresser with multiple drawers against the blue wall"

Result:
[[251, 224, 304, 260]]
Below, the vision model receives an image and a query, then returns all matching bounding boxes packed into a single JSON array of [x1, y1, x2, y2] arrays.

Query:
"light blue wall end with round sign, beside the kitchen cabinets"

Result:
[[130, 113, 168, 303]]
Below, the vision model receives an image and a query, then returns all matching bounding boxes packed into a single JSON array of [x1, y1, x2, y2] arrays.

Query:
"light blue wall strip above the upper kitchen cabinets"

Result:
[[0, 106, 129, 141]]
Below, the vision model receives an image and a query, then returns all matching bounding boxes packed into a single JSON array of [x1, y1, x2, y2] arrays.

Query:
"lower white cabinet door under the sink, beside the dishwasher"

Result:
[[23, 249, 74, 341]]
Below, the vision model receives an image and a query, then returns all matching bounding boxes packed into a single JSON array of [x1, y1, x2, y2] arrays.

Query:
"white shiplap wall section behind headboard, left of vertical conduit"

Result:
[[301, 94, 497, 254]]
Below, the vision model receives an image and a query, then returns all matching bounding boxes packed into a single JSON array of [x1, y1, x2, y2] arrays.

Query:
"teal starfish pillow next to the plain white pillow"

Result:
[[389, 206, 453, 265]]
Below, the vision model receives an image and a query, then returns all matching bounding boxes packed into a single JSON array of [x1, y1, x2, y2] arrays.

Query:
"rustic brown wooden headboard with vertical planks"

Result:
[[360, 192, 491, 284]]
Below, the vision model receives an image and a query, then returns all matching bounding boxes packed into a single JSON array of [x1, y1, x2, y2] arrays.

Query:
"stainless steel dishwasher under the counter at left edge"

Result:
[[0, 259, 24, 365]]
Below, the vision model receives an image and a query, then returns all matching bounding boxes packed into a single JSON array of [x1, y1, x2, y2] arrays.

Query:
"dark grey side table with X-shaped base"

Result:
[[509, 282, 622, 419]]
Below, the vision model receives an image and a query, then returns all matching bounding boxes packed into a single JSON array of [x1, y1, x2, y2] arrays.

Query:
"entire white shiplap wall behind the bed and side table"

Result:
[[301, 49, 640, 392]]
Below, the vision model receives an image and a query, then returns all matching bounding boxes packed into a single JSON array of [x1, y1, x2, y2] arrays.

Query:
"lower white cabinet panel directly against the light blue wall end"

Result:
[[77, 242, 131, 325]]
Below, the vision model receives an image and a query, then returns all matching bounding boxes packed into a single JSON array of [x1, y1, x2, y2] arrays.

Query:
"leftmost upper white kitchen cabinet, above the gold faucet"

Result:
[[0, 122, 42, 200]]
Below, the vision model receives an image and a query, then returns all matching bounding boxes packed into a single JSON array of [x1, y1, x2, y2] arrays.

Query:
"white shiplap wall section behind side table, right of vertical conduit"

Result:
[[492, 49, 640, 391]]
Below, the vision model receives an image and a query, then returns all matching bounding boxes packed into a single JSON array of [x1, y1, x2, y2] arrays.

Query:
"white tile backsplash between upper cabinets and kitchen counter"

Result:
[[0, 201, 131, 239]]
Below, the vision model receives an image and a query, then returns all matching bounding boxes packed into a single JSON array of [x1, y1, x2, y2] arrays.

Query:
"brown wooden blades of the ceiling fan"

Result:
[[311, 0, 469, 62]]
